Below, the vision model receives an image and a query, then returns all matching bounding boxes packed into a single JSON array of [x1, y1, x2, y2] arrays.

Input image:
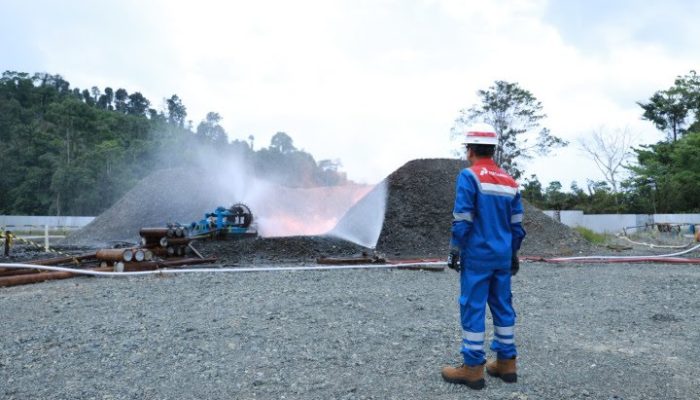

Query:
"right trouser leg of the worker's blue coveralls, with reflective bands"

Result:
[[488, 269, 517, 358]]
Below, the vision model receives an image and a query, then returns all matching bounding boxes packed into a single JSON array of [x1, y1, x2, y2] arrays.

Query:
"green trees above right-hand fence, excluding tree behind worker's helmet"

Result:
[[521, 71, 700, 214]]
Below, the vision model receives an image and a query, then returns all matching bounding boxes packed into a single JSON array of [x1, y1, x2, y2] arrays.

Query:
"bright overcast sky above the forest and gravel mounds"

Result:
[[0, 0, 700, 187]]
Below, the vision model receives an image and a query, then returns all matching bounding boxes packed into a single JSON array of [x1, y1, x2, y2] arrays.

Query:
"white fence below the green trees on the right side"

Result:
[[544, 210, 700, 233]]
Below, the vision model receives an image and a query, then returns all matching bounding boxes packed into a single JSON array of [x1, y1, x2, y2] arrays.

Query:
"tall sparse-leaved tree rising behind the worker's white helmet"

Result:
[[452, 81, 568, 178]]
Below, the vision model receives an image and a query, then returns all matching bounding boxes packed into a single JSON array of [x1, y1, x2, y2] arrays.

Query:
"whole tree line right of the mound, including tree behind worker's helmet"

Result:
[[460, 71, 700, 214]]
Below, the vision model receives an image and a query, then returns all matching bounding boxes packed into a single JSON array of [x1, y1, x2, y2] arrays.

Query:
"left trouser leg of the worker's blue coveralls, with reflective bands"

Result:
[[459, 268, 493, 366]]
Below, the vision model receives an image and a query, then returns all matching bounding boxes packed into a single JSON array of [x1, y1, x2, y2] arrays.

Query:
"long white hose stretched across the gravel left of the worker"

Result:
[[0, 261, 445, 276]]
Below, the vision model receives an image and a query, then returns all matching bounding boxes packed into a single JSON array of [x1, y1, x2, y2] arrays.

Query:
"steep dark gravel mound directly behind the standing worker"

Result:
[[338, 159, 592, 256]]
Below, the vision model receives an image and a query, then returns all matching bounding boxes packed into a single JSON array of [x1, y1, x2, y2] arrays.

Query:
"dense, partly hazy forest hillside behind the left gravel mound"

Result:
[[0, 71, 346, 215]]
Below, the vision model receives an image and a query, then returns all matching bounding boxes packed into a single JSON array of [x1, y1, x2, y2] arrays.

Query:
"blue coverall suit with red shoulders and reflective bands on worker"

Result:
[[451, 158, 525, 366]]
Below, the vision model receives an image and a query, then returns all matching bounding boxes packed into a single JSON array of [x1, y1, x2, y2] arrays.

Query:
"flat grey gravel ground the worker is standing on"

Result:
[[0, 263, 700, 399]]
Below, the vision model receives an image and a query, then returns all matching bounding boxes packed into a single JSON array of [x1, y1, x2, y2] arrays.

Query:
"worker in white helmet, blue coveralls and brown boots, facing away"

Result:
[[442, 124, 525, 389]]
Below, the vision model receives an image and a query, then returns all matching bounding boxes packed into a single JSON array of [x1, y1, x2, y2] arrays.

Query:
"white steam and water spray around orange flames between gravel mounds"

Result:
[[185, 141, 386, 248]]
